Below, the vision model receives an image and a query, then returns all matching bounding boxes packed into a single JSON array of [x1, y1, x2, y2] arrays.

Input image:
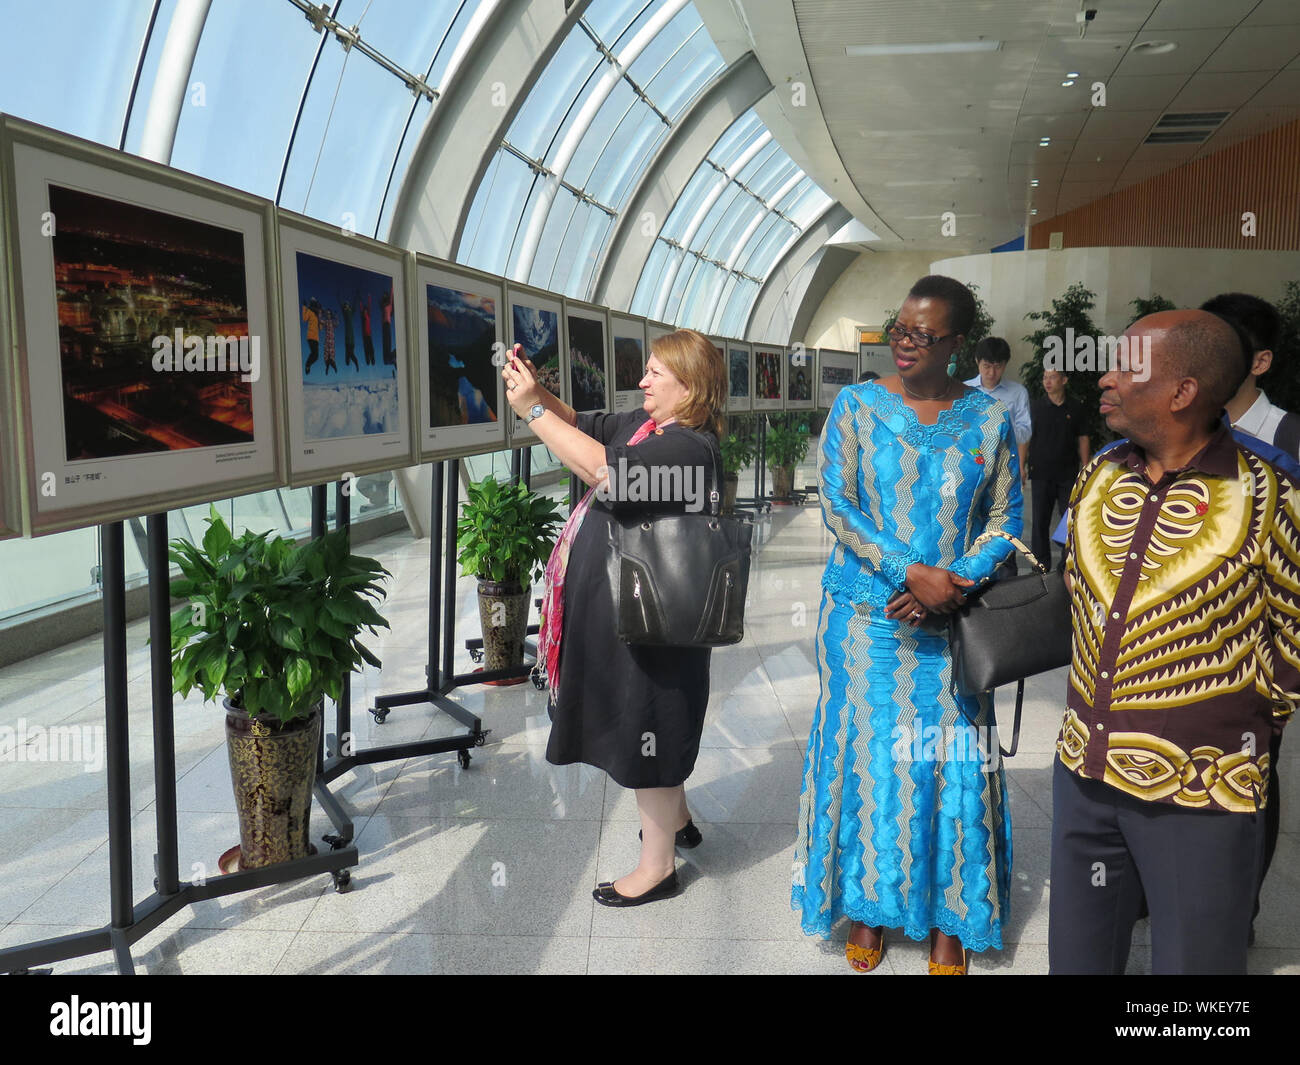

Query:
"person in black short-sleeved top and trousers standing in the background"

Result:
[[1028, 369, 1091, 570]]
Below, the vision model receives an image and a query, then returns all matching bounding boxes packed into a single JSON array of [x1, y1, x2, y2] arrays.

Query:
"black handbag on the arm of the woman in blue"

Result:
[[948, 533, 1070, 758]]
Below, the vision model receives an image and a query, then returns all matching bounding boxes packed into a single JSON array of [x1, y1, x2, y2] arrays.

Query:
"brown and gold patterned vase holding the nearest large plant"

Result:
[[225, 700, 321, 869]]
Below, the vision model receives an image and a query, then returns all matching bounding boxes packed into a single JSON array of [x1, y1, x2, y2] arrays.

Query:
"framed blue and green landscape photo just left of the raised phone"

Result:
[[412, 255, 510, 462]]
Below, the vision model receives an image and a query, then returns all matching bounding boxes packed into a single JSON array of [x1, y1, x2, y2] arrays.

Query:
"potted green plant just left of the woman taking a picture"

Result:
[[456, 476, 560, 672]]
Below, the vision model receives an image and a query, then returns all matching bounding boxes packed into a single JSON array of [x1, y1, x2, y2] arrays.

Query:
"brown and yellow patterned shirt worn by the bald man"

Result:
[[1057, 427, 1300, 813]]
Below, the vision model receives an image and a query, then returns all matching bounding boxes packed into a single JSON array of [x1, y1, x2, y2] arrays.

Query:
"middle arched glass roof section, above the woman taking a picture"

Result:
[[458, 0, 724, 298]]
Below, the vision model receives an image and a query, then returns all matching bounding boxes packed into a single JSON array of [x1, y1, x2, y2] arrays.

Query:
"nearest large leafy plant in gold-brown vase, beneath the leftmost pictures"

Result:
[[169, 507, 389, 869]]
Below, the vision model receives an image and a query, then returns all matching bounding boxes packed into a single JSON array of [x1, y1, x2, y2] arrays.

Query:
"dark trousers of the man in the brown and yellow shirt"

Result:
[[1048, 759, 1264, 975]]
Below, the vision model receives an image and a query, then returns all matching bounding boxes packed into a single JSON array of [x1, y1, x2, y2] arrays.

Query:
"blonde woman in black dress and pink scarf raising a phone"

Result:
[[502, 329, 727, 906]]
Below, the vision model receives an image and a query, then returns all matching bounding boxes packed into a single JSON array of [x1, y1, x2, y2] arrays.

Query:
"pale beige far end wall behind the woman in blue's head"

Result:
[[803, 251, 932, 351]]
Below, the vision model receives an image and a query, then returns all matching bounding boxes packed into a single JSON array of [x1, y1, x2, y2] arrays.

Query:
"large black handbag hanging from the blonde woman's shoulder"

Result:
[[608, 457, 754, 648]]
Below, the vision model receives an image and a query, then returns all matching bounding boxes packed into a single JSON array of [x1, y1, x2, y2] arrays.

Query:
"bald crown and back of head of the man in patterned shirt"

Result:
[[1128, 311, 1249, 420]]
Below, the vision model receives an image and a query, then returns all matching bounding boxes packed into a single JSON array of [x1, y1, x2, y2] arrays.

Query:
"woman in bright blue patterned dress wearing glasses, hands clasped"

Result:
[[792, 276, 1022, 975]]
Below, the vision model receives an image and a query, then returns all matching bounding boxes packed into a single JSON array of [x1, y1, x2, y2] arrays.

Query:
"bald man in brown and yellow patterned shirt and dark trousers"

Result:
[[1048, 311, 1300, 973]]
